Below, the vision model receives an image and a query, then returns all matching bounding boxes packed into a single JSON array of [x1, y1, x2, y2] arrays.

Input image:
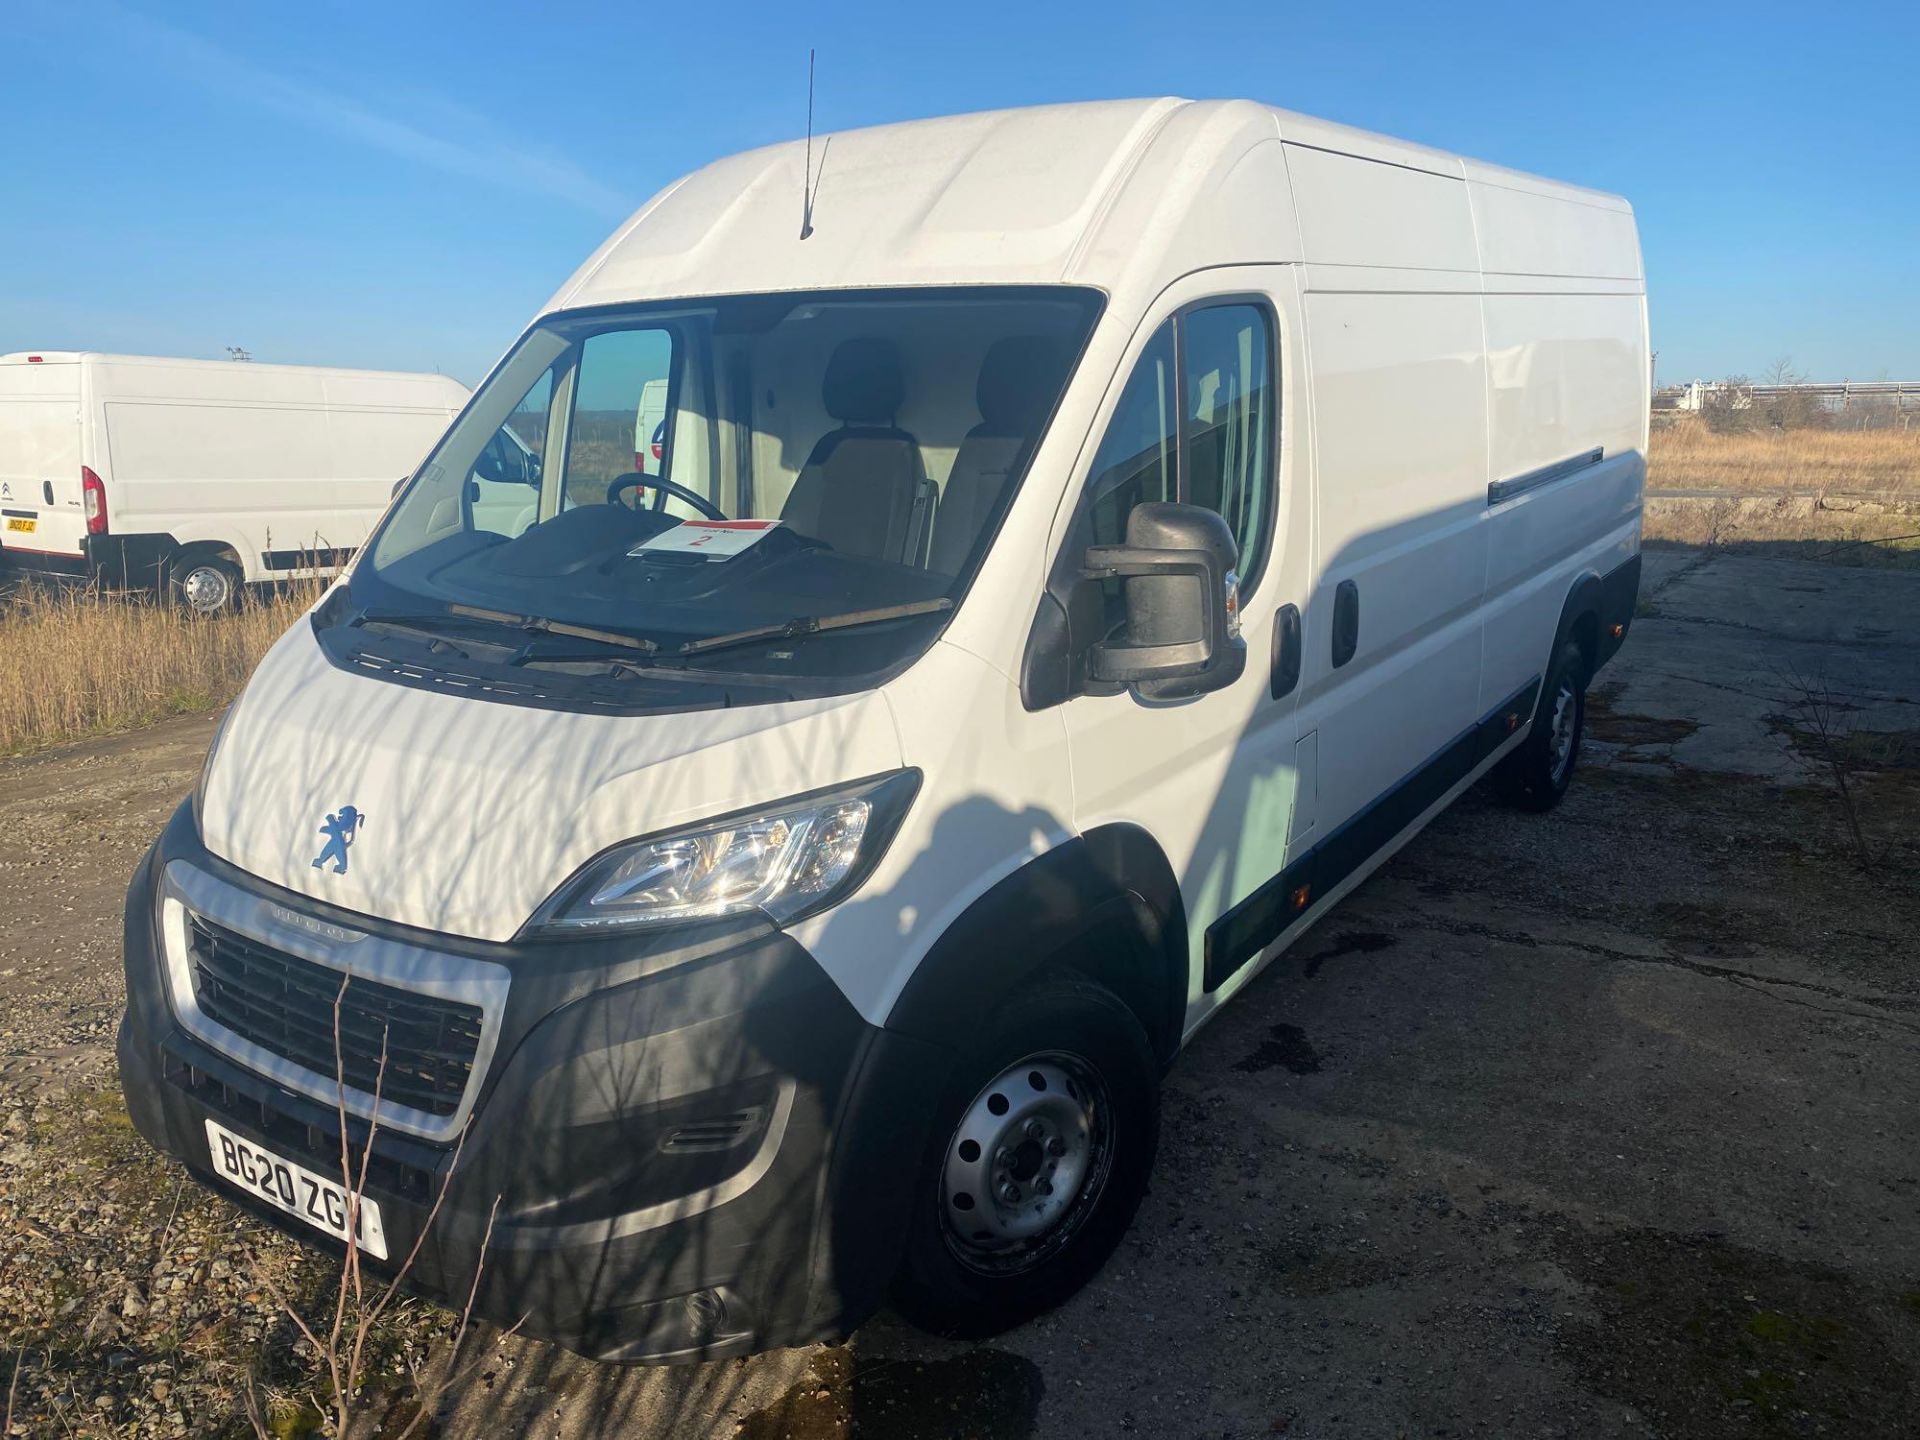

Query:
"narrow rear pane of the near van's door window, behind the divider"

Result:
[[1181, 305, 1275, 591]]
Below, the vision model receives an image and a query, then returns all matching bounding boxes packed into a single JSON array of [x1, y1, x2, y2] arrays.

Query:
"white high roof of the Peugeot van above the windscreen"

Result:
[[549, 98, 1642, 318]]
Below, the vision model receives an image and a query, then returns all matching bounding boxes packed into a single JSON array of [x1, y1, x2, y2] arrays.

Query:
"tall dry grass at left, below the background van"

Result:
[[0, 582, 323, 755]]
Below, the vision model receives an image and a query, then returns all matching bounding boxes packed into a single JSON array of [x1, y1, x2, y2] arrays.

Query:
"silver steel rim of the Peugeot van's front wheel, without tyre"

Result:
[[941, 1050, 1114, 1275]]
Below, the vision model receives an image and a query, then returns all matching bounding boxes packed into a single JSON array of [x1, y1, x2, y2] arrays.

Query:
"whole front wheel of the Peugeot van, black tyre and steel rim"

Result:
[[895, 975, 1160, 1336]]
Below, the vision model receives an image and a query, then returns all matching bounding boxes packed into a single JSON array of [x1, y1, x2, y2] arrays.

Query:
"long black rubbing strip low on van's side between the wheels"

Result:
[[1206, 676, 1540, 995]]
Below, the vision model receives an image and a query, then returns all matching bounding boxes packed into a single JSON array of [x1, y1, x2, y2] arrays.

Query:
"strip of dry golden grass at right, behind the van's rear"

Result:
[[1647, 420, 1920, 495]]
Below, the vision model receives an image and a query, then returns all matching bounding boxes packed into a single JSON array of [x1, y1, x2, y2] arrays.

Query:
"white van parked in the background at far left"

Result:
[[0, 351, 467, 614]]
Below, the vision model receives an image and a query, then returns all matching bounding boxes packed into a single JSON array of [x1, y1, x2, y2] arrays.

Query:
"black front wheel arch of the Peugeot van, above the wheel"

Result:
[[885, 824, 1190, 1064]]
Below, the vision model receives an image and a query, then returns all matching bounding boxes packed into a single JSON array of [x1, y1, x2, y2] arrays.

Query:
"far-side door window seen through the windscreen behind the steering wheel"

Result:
[[563, 326, 674, 507]]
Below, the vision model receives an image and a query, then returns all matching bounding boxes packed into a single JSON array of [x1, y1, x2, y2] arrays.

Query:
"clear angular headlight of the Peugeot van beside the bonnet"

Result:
[[528, 770, 920, 933]]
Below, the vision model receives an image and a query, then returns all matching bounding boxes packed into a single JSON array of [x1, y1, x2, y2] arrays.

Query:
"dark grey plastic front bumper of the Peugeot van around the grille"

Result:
[[119, 806, 947, 1361]]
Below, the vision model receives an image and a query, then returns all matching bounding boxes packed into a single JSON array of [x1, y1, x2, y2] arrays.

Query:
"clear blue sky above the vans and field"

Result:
[[0, 0, 1920, 382]]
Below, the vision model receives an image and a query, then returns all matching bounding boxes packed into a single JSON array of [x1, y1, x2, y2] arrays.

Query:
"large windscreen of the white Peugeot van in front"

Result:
[[353, 286, 1098, 687]]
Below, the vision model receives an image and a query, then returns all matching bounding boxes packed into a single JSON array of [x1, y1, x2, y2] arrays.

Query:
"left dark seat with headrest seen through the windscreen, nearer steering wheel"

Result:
[[780, 336, 935, 564]]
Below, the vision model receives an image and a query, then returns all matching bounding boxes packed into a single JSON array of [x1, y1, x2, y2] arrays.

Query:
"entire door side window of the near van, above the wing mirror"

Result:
[[1087, 303, 1277, 587]]
